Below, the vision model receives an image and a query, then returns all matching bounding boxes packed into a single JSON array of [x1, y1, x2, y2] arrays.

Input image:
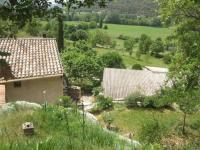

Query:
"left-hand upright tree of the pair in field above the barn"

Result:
[[139, 34, 152, 54]]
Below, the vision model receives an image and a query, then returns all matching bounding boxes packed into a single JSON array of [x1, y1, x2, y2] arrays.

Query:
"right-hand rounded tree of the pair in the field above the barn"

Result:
[[150, 38, 164, 57]]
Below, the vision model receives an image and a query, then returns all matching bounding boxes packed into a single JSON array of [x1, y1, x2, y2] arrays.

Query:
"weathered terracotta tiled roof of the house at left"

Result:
[[0, 38, 63, 79]]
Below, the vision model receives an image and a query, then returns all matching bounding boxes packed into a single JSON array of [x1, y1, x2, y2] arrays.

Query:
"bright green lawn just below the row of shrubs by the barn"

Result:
[[97, 104, 200, 140]]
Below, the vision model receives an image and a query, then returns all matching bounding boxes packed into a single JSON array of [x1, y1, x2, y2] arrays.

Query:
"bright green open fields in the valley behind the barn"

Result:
[[67, 21, 173, 68]]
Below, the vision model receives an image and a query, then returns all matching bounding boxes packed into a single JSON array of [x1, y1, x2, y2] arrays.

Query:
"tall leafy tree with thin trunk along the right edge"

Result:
[[158, 0, 200, 133]]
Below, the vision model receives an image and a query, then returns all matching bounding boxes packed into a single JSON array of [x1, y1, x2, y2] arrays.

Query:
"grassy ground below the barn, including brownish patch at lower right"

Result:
[[96, 104, 200, 149]]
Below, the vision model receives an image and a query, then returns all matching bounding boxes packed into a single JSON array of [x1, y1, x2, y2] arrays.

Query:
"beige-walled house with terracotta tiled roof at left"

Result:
[[0, 38, 63, 105]]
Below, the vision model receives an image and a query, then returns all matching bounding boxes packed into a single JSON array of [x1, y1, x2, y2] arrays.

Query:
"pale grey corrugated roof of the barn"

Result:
[[103, 68, 167, 100]]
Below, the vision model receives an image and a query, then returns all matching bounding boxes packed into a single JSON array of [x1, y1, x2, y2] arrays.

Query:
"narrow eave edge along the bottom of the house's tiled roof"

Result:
[[0, 74, 63, 84]]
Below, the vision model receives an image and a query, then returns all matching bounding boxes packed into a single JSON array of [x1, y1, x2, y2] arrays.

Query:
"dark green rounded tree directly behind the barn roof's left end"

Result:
[[100, 52, 125, 68]]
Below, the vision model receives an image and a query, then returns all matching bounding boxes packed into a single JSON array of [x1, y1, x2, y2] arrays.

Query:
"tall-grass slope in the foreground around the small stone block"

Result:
[[0, 106, 133, 150]]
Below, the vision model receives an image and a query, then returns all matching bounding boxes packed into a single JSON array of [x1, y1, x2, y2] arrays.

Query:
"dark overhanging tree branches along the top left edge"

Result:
[[0, 0, 110, 26]]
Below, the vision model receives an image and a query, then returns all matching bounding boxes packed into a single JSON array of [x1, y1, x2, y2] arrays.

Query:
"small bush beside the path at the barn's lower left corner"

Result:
[[96, 95, 114, 110]]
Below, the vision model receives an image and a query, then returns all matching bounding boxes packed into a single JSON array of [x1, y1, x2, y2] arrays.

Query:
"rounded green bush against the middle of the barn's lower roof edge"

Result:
[[124, 92, 144, 108]]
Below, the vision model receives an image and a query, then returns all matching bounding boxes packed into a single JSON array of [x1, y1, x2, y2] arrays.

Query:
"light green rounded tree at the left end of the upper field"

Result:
[[91, 30, 111, 47]]
